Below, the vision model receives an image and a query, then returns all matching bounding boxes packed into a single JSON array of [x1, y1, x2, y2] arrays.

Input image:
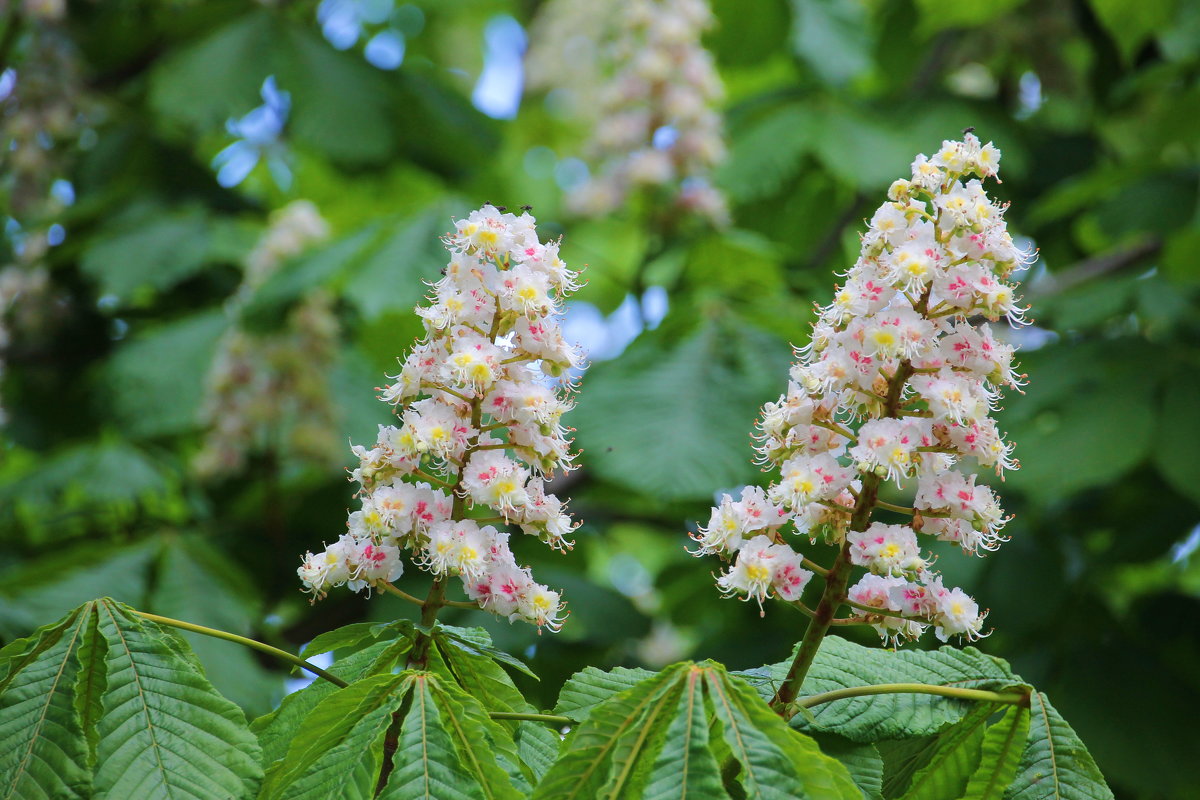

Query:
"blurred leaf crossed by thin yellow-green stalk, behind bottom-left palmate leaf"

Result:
[[150, 536, 280, 716]]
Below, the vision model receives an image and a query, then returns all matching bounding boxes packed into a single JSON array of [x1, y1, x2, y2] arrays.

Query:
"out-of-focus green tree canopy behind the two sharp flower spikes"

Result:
[[0, 0, 1200, 798]]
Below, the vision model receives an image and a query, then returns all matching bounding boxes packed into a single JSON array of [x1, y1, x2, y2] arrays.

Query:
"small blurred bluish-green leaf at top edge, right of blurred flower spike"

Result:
[[792, 0, 872, 86]]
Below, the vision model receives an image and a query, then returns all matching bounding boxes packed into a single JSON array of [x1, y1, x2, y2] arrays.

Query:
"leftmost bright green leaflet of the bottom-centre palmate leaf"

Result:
[[533, 664, 689, 800]]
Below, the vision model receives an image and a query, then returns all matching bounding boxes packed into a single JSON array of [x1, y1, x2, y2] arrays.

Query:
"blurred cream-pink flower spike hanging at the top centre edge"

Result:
[[529, 0, 728, 224]]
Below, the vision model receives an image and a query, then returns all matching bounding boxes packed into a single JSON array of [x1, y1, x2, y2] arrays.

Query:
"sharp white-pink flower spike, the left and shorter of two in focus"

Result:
[[299, 205, 581, 630]]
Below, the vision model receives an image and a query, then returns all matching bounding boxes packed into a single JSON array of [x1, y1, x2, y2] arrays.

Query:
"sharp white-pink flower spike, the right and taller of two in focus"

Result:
[[694, 133, 1027, 642]]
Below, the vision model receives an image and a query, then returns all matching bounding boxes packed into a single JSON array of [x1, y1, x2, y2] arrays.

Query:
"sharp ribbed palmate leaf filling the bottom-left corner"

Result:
[[0, 599, 262, 800]]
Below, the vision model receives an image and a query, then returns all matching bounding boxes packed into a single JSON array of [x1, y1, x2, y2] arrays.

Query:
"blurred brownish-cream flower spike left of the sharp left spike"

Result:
[[193, 200, 341, 477]]
